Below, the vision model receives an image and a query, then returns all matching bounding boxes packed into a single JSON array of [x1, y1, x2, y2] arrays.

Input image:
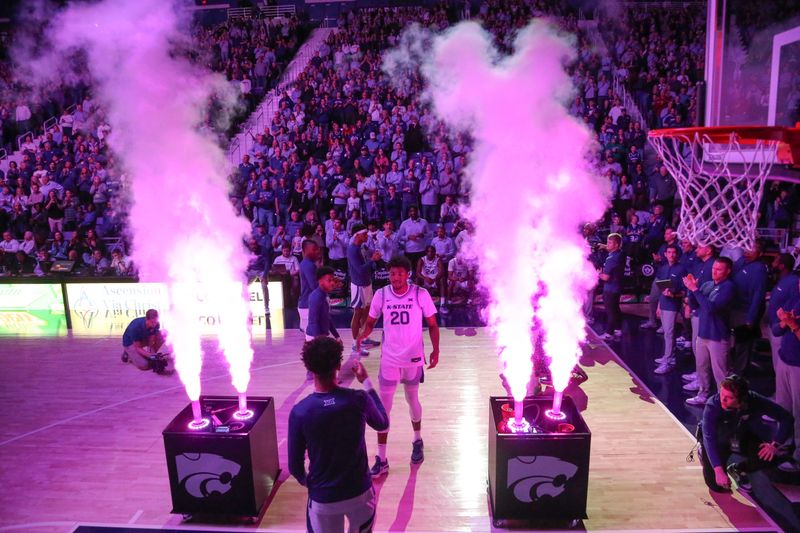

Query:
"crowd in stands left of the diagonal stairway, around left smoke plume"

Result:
[[0, 11, 308, 276]]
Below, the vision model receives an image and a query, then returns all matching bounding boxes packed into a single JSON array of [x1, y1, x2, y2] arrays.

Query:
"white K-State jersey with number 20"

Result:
[[369, 285, 436, 367]]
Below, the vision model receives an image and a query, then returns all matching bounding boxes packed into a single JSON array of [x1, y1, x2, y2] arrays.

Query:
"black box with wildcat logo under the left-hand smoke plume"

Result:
[[163, 396, 280, 517]]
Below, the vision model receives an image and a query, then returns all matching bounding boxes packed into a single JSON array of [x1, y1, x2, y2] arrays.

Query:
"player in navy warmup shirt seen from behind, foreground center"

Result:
[[288, 337, 389, 533]]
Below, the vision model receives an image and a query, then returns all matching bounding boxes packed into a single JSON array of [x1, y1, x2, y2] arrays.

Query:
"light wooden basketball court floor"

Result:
[[0, 329, 771, 532]]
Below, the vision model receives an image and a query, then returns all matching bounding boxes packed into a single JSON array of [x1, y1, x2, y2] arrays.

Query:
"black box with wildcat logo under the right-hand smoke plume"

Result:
[[489, 396, 591, 525]]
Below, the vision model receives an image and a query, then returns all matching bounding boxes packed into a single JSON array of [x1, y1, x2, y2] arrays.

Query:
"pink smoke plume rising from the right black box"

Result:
[[386, 20, 608, 400]]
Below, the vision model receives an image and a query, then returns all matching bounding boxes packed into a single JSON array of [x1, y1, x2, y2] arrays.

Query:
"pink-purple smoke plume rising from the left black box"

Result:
[[17, 0, 253, 400]]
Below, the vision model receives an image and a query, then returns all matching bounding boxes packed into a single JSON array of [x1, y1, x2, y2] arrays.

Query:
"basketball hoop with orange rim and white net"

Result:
[[648, 126, 800, 250]]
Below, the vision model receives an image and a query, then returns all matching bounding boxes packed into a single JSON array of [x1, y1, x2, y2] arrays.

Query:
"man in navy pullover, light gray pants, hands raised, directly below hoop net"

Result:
[[683, 257, 736, 405]]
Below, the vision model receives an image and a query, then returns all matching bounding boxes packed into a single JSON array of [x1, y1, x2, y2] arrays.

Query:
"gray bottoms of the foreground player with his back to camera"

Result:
[[306, 487, 377, 533]]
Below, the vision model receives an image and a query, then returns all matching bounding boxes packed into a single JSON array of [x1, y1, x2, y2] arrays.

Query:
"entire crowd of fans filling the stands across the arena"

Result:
[[0, 0, 796, 306]]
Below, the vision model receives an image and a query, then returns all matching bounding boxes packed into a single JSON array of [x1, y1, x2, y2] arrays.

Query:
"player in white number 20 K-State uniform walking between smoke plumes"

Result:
[[356, 256, 439, 477]]
